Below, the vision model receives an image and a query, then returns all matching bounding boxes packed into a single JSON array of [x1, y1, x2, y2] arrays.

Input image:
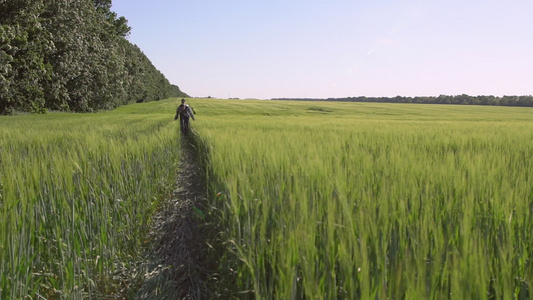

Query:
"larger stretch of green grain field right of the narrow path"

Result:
[[191, 99, 533, 299]]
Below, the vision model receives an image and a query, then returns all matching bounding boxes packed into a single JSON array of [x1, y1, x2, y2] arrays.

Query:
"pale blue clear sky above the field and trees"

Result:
[[112, 0, 533, 99]]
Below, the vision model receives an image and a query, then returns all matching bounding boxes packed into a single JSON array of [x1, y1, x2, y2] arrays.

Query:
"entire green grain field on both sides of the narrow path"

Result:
[[0, 99, 533, 299]]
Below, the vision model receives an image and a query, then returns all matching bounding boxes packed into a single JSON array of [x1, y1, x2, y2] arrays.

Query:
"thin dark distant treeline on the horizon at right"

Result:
[[272, 94, 533, 107]]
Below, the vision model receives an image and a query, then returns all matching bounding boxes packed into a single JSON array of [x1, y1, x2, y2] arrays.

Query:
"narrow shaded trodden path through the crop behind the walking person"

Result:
[[136, 137, 213, 299]]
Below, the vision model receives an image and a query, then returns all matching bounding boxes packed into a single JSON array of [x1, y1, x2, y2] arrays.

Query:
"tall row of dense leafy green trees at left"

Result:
[[0, 0, 187, 114]]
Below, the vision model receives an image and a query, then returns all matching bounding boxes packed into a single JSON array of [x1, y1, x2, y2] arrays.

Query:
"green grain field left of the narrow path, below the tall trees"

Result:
[[0, 100, 179, 299]]
